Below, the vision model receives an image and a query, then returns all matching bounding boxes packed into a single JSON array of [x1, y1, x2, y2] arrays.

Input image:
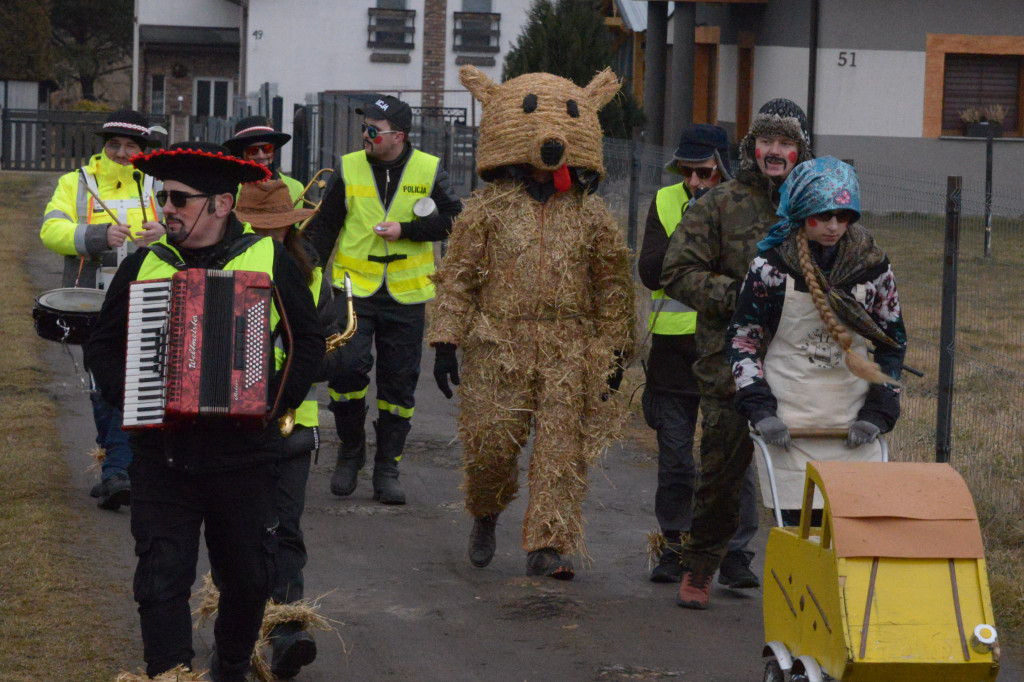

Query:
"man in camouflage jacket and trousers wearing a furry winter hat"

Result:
[[662, 99, 812, 608]]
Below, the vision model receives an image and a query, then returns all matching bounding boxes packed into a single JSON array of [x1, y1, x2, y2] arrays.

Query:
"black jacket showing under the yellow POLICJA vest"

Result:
[[303, 144, 462, 271]]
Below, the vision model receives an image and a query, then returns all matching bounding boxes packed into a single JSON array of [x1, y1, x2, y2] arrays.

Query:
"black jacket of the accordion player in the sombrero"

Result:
[[85, 213, 325, 473]]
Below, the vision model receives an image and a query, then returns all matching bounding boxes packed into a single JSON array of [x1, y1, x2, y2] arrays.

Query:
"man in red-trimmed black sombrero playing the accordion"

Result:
[[86, 142, 325, 682]]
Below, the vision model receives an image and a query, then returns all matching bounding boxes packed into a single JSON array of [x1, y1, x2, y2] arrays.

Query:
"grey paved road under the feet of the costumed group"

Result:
[[30, 232, 1021, 682]]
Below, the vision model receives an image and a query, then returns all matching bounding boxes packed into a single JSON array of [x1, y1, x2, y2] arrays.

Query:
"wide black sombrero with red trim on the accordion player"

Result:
[[131, 141, 270, 195]]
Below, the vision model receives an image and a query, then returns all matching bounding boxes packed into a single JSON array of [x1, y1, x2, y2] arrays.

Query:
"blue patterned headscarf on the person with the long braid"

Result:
[[758, 157, 860, 253]]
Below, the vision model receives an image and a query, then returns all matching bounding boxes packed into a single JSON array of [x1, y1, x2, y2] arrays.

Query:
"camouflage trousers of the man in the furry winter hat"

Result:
[[682, 395, 754, 573]]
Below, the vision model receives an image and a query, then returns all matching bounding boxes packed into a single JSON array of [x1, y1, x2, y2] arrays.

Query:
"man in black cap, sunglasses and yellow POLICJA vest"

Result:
[[305, 95, 461, 505]]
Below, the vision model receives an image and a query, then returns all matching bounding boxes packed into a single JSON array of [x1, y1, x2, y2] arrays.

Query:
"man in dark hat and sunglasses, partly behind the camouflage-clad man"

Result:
[[637, 123, 760, 588]]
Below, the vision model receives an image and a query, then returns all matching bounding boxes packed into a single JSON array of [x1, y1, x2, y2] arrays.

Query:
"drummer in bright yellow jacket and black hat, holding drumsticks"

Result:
[[39, 110, 164, 511]]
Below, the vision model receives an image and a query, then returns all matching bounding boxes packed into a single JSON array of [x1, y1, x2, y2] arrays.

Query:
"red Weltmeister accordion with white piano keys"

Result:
[[123, 268, 273, 429]]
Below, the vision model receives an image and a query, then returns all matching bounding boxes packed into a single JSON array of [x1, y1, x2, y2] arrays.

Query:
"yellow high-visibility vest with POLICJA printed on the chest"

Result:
[[332, 150, 439, 303]]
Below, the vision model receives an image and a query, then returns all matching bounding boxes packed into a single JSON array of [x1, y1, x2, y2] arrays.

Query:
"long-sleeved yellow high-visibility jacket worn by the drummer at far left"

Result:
[[39, 153, 164, 287]]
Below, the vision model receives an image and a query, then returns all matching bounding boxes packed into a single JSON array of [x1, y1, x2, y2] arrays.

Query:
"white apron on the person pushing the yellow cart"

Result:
[[758, 276, 882, 509]]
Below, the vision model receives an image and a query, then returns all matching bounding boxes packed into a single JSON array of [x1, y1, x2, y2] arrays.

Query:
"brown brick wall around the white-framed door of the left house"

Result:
[[139, 47, 239, 116]]
